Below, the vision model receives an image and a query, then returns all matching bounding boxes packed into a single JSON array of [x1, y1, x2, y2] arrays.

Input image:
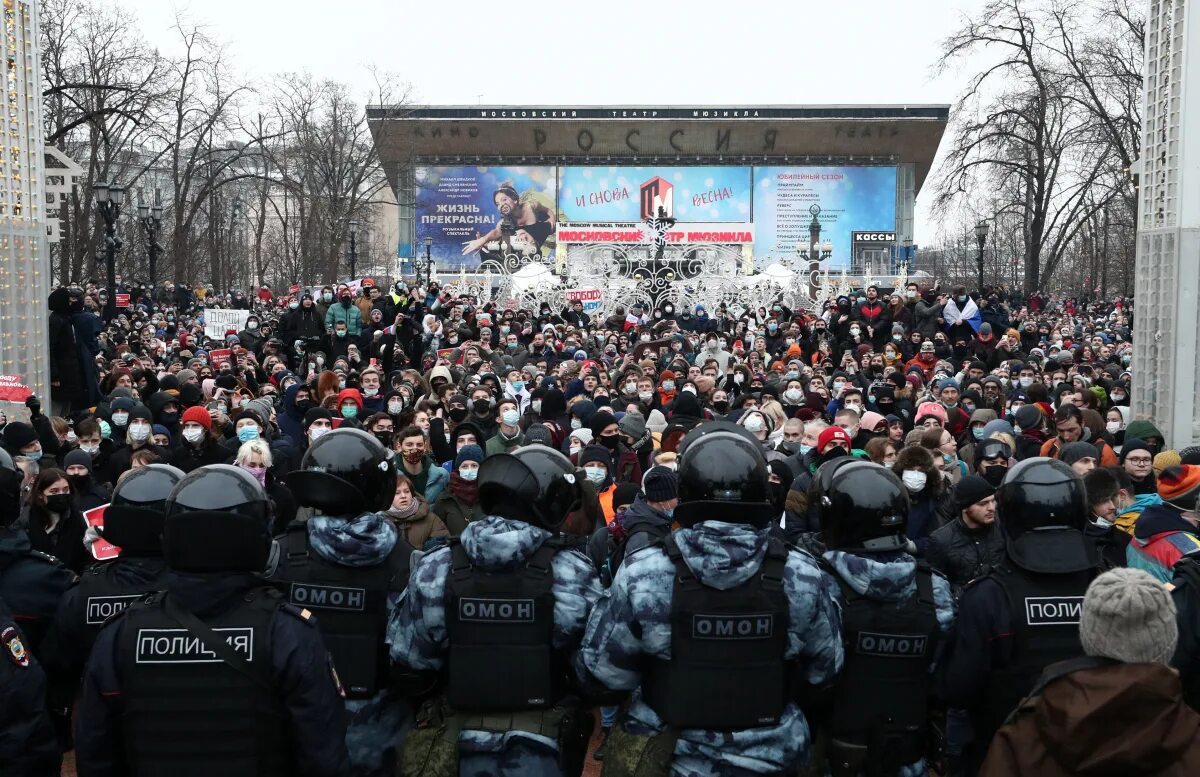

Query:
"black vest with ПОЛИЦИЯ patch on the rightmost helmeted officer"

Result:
[[976, 562, 1096, 741]]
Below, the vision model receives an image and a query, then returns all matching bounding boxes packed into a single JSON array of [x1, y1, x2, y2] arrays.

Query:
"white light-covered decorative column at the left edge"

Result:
[[0, 0, 50, 396]]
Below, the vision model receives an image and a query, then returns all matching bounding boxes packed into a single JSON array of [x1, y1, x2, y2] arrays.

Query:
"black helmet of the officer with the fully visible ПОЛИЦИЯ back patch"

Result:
[[162, 464, 271, 573]]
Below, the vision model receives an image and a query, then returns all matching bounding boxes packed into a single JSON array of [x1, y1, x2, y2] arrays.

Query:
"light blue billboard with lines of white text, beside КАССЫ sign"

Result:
[[754, 167, 896, 267]]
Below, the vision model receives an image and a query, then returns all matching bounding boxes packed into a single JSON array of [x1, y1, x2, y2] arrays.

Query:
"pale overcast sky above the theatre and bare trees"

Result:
[[118, 0, 983, 243]]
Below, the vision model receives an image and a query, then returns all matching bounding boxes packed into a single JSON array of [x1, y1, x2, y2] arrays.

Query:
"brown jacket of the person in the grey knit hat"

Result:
[[979, 663, 1200, 777]]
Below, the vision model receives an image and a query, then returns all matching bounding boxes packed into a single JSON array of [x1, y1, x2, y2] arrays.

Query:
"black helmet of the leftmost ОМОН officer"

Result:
[[284, 429, 396, 516]]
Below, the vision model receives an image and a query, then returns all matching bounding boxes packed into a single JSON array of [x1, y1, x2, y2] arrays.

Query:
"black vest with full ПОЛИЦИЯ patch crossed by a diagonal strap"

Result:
[[118, 588, 296, 777]]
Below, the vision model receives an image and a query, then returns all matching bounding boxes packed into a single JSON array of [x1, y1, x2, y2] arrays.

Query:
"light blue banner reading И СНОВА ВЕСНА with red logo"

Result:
[[558, 167, 751, 223]]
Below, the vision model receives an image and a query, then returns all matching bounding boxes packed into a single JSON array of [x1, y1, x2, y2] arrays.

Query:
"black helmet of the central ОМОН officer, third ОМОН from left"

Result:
[[674, 421, 776, 528]]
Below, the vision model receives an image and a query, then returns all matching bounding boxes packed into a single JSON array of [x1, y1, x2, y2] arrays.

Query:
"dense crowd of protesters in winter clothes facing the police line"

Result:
[[11, 269, 1200, 773]]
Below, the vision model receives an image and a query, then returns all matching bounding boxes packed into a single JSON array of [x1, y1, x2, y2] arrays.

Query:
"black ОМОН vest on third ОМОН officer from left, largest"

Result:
[[642, 536, 791, 730]]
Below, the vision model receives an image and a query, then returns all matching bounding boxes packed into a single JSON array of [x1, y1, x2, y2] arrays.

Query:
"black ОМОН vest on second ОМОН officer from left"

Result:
[[445, 540, 566, 711]]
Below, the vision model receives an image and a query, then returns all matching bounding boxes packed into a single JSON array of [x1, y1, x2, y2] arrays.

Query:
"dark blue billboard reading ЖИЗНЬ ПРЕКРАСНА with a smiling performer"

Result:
[[415, 165, 557, 272]]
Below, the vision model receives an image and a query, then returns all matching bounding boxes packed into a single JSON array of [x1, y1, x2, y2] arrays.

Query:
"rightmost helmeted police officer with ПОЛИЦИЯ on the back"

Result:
[[938, 457, 1099, 773]]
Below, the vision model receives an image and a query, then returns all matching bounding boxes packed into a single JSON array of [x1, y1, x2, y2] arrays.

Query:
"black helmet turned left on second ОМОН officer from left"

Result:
[[478, 445, 583, 531]]
